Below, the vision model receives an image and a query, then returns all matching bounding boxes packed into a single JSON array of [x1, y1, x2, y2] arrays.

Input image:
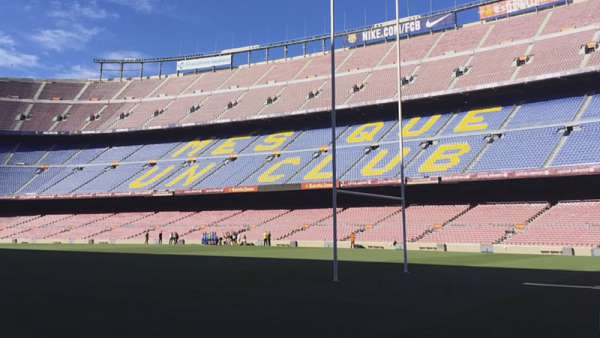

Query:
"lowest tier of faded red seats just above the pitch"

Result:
[[0, 201, 600, 247]]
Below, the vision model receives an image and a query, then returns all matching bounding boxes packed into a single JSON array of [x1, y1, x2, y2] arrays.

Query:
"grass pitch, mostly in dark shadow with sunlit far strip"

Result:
[[0, 244, 600, 338]]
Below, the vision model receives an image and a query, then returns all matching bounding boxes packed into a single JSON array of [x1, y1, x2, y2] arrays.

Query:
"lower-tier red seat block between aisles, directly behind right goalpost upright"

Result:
[[356, 205, 469, 243]]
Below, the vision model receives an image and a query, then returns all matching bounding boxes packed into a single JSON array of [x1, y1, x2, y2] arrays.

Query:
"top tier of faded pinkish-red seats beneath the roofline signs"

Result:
[[0, 0, 600, 132]]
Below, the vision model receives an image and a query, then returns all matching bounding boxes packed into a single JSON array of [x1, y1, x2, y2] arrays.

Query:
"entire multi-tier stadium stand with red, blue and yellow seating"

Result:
[[0, 0, 600, 255]]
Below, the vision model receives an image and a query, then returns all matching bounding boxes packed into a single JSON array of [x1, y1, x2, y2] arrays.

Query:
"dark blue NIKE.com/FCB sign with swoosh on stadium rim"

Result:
[[346, 13, 456, 44]]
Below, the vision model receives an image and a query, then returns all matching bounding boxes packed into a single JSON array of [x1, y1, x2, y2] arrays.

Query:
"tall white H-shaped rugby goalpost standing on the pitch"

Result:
[[329, 0, 408, 282]]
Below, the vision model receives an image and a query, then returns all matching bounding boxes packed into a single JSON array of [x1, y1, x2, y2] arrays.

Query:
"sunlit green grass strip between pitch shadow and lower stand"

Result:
[[0, 244, 600, 272]]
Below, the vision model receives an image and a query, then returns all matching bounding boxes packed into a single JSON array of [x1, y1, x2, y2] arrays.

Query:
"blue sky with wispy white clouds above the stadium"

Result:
[[0, 0, 478, 78]]
